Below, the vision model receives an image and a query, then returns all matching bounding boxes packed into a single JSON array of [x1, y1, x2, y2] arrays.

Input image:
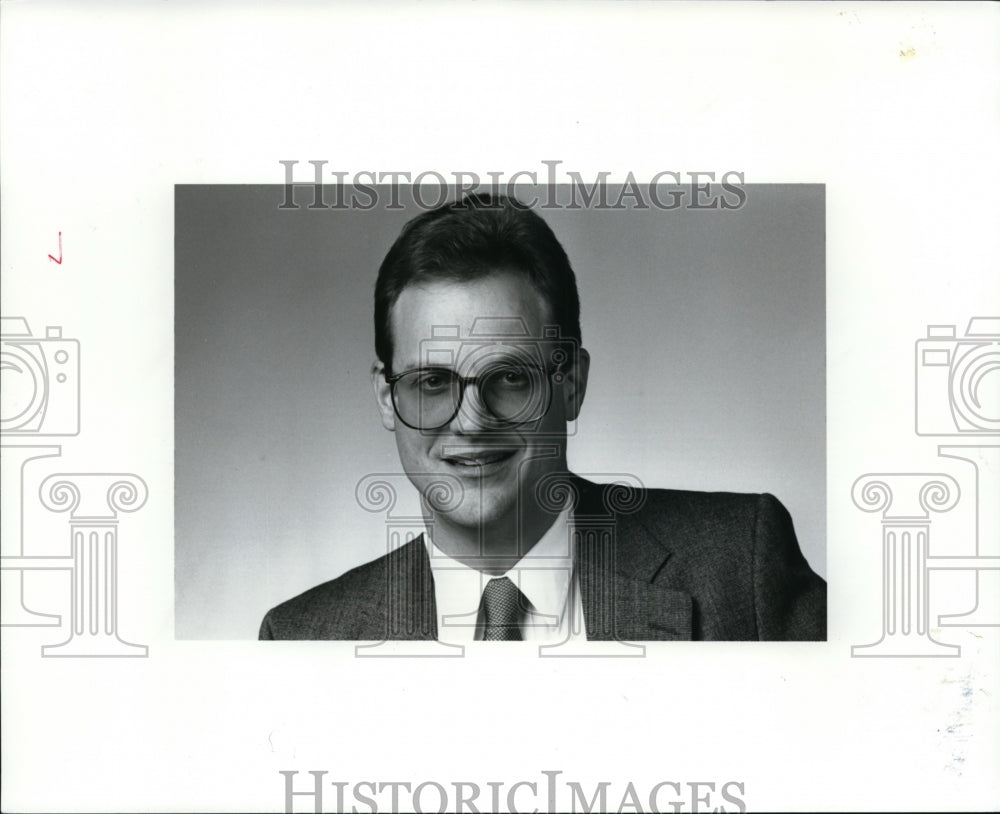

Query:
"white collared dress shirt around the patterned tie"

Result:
[[424, 508, 587, 644]]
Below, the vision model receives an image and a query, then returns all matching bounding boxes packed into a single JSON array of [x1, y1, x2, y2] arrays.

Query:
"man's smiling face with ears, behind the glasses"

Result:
[[372, 273, 588, 542]]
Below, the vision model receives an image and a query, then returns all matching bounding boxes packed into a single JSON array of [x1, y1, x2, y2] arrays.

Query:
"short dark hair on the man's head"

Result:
[[375, 194, 581, 373]]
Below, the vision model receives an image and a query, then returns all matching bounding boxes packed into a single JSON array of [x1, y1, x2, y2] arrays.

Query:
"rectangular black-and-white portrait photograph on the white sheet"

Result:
[[175, 183, 826, 645]]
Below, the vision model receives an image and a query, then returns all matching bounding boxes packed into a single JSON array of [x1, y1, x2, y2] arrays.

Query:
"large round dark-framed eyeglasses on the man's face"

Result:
[[386, 362, 562, 430]]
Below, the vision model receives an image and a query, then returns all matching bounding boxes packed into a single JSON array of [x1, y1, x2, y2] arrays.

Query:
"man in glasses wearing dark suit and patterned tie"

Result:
[[260, 195, 826, 643]]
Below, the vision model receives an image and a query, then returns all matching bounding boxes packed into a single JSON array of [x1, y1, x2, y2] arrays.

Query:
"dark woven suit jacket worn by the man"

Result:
[[260, 476, 826, 641]]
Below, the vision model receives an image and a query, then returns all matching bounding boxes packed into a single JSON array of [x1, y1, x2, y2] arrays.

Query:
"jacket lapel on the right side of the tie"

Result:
[[573, 477, 692, 641]]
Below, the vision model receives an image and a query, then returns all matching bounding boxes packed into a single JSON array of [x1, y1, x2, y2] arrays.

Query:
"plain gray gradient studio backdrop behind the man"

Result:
[[175, 184, 826, 639]]
